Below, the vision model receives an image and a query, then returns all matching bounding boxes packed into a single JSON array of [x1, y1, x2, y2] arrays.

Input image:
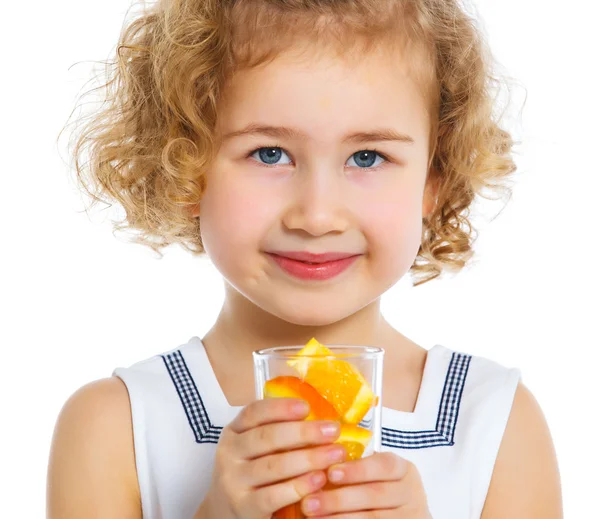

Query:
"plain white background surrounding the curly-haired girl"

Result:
[[0, 0, 600, 519]]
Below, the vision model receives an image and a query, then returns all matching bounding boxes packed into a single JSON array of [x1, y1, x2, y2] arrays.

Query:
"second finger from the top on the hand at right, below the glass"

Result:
[[302, 481, 405, 517]]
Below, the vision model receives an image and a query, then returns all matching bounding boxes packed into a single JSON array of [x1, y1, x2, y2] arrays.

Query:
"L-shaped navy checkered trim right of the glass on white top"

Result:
[[381, 352, 472, 449]]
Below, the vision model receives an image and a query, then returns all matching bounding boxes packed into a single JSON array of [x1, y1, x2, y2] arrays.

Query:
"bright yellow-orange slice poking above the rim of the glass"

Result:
[[288, 339, 375, 424]]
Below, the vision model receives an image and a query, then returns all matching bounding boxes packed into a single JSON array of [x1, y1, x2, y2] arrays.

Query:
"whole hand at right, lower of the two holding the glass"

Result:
[[302, 452, 431, 519]]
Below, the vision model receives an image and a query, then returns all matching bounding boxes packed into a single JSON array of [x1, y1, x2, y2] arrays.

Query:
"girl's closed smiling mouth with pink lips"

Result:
[[267, 251, 362, 281]]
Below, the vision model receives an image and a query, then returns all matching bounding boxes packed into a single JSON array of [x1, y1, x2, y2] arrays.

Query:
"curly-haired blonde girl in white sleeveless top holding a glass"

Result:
[[48, 0, 562, 519]]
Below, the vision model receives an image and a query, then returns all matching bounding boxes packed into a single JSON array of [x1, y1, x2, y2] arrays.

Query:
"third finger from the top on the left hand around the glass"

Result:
[[241, 445, 346, 487]]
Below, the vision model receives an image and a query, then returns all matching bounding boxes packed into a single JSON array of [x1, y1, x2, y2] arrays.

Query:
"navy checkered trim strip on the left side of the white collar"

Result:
[[161, 350, 223, 443]]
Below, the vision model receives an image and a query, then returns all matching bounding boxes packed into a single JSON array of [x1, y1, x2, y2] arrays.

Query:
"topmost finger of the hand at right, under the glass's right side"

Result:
[[327, 452, 410, 485]]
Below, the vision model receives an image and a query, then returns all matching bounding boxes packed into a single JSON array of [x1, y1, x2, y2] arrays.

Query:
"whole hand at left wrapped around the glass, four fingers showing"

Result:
[[194, 398, 346, 519]]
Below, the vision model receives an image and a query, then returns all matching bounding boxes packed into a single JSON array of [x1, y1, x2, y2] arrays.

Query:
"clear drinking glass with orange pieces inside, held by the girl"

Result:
[[253, 345, 384, 519]]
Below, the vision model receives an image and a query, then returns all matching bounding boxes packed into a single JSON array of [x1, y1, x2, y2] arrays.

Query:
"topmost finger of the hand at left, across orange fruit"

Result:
[[228, 398, 310, 433]]
